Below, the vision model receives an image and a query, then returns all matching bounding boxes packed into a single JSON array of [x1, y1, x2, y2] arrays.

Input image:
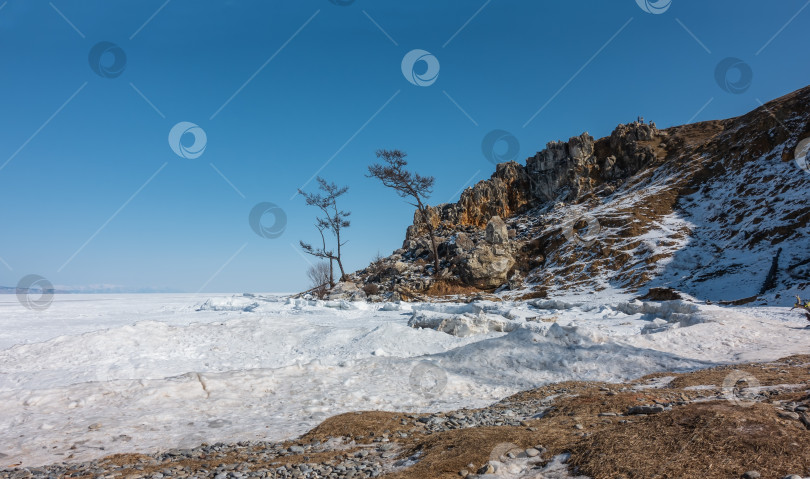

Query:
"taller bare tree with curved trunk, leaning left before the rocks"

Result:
[[368, 150, 439, 275]]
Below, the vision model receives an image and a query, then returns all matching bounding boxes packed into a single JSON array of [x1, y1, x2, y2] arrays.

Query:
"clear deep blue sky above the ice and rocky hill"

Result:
[[0, 0, 810, 292]]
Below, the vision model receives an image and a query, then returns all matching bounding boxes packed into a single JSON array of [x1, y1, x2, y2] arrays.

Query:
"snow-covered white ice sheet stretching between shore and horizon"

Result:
[[0, 294, 810, 466]]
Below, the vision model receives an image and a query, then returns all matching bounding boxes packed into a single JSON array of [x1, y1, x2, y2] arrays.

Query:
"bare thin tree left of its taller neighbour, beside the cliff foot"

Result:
[[298, 176, 351, 287]]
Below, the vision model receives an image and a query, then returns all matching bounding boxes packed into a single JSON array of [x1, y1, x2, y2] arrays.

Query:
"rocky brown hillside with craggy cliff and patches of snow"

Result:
[[340, 87, 810, 305]]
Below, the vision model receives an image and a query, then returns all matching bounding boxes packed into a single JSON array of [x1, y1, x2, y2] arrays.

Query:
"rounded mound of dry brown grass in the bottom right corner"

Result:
[[571, 401, 810, 479]]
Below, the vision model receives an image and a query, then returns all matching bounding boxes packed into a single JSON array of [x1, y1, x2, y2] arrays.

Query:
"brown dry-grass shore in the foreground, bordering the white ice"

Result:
[[82, 355, 810, 479]]
